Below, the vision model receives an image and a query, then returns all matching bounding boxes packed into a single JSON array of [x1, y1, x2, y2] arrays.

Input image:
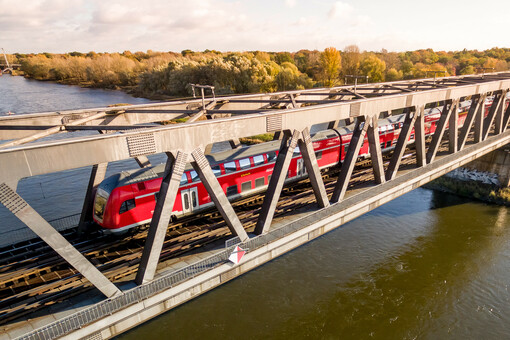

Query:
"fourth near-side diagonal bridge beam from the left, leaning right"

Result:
[[255, 130, 300, 235]]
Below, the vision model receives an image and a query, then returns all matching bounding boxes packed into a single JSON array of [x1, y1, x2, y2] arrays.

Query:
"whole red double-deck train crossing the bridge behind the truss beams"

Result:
[[93, 98, 492, 234]]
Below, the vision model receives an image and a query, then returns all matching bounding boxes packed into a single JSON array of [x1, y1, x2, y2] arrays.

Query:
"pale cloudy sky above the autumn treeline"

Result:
[[0, 0, 510, 53]]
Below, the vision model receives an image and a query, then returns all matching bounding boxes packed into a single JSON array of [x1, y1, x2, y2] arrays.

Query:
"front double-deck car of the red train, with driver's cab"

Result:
[[93, 130, 340, 232]]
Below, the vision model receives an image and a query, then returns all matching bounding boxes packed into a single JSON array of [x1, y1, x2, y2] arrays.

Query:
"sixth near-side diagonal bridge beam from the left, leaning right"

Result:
[[331, 116, 369, 203]]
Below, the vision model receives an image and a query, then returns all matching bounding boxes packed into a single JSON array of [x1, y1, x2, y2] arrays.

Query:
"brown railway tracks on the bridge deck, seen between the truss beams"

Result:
[[0, 136, 458, 325]]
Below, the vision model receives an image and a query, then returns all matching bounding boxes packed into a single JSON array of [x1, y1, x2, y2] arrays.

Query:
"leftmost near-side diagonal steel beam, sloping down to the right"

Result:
[[0, 183, 120, 297]]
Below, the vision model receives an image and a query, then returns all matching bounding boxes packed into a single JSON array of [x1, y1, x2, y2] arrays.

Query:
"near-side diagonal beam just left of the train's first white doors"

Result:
[[135, 151, 188, 285]]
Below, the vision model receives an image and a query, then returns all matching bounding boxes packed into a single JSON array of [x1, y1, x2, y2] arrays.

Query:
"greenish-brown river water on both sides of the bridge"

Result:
[[0, 77, 510, 340]]
